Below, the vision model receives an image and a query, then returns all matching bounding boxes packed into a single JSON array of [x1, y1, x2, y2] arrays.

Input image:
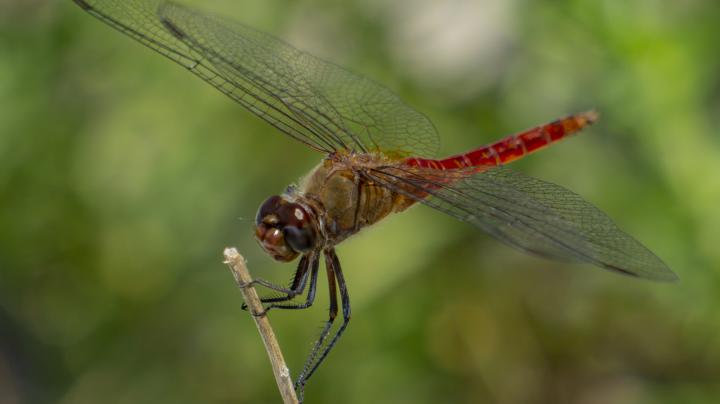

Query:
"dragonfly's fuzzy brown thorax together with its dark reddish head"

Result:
[[255, 155, 414, 261]]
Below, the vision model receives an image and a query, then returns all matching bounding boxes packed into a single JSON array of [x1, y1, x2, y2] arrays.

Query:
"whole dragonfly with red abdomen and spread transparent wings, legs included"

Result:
[[73, 0, 677, 398]]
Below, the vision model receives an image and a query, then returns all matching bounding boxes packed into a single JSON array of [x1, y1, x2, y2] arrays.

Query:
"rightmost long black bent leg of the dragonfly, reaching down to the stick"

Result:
[[295, 248, 351, 394]]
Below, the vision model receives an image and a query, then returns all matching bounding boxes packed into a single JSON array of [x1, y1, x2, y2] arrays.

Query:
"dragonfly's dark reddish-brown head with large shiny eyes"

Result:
[[255, 195, 317, 262]]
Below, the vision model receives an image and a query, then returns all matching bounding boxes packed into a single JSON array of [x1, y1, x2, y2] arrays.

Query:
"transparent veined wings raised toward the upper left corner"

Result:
[[73, 0, 438, 158]]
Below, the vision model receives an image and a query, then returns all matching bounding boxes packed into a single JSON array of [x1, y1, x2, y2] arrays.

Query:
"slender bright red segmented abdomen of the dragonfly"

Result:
[[405, 111, 598, 170]]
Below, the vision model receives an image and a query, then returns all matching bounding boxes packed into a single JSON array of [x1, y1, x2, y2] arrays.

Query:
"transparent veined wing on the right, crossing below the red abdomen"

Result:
[[368, 166, 677, 281]]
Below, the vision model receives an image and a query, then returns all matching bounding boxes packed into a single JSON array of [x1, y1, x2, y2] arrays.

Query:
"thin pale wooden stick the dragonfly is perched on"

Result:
[[224, 248, 298, 404]]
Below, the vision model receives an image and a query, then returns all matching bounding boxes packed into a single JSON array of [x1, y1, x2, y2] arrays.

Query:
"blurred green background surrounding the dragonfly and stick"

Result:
[[0, 0, 720, 404]]
